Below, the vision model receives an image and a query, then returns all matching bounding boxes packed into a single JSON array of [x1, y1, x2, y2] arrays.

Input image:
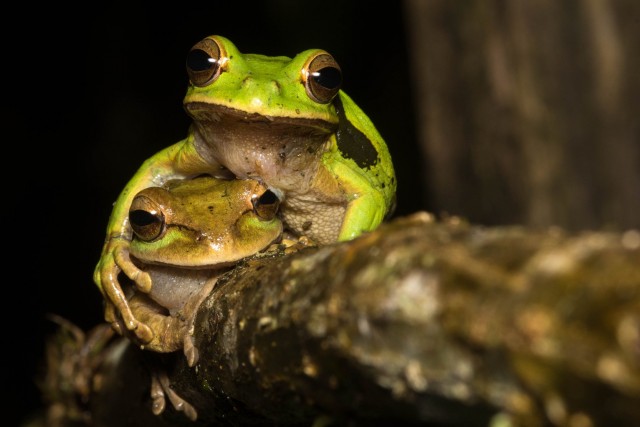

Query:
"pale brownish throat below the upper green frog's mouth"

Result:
[[187, 104, 337, 192]]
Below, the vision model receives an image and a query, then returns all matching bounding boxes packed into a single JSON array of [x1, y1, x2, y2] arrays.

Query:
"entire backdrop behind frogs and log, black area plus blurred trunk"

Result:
[[11, 0, 640, 425]]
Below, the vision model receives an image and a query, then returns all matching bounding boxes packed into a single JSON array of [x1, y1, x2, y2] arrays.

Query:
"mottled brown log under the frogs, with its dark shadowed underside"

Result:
[[36, 213, 640, 427]]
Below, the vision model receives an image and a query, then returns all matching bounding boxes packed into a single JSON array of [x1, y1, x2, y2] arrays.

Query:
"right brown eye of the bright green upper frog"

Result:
[[302, 52, 342, 104]]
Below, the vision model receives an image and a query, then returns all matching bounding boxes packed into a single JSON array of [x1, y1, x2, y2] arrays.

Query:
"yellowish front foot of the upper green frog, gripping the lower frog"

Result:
[[95, 238, 153, 343]]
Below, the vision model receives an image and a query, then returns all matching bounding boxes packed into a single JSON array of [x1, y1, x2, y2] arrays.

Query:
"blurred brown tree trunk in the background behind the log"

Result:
[[405, 0, 640, 230]]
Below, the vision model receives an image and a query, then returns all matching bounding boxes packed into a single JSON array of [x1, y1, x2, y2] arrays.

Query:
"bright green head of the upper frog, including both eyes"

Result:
[[184, 36, 342, 133]]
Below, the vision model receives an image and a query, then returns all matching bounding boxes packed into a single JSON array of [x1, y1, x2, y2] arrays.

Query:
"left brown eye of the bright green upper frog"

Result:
[[187, 37, 227, 87]]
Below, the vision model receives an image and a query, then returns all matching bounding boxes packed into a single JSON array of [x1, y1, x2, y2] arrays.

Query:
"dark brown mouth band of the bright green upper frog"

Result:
[[185, 102, 338, 135]]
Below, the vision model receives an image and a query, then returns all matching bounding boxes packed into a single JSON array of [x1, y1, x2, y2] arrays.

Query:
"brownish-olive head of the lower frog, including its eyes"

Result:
[[129, 176, 282, 269]]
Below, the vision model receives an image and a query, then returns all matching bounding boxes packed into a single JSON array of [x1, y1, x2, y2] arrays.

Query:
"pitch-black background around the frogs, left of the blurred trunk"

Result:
[[11, 0, 425, 425]]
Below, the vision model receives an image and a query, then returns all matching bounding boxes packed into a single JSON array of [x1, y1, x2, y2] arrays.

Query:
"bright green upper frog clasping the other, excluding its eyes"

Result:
[[94, 36, 396, 341]]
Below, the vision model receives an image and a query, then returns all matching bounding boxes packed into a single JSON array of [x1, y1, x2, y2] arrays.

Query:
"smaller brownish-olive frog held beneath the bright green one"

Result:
[[117, 176, 282, 420]]
